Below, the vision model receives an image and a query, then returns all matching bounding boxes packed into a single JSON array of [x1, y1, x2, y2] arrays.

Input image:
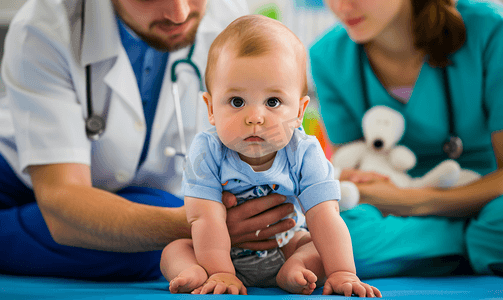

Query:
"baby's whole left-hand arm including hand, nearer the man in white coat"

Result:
[[185, 197, 246, 294]]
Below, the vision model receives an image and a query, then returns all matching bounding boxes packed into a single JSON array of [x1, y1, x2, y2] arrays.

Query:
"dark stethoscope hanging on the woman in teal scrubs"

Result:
[[359, 45, 463, 159]]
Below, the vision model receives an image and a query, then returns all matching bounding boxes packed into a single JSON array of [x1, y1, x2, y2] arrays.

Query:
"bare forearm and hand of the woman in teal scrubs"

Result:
[[358, 131, 503, 217]]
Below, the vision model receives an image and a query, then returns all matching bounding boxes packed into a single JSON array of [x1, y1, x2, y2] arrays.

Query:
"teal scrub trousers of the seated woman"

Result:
[[341, 196, 503, 278]]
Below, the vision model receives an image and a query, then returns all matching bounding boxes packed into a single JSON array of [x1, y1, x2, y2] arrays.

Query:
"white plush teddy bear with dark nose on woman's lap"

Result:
[[331, 106, 480, 210]]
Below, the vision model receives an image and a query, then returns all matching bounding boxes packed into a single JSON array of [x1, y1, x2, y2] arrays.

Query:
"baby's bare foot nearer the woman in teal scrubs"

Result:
[[276, 262, 318, 295]]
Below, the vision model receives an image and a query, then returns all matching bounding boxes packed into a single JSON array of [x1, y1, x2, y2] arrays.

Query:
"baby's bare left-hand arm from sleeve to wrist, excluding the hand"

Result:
[[185, 197, 235, 276]]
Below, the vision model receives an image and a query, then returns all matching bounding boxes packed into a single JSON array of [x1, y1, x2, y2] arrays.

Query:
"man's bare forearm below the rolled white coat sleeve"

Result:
[[28, 164, 190, 252]]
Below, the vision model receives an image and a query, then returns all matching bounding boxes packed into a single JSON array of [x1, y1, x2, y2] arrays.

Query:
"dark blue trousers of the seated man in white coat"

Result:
[[0, 155, 183, 281]]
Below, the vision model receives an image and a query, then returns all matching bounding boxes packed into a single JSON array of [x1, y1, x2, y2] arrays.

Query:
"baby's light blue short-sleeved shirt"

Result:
[[182, 128, 341, 213]]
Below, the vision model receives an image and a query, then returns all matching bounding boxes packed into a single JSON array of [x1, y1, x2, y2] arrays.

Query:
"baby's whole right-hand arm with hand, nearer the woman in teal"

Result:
[[306, 200, 381, 297]]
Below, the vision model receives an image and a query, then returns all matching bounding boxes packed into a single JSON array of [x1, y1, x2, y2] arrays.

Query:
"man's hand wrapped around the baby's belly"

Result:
[[222, 192, 295, 250]]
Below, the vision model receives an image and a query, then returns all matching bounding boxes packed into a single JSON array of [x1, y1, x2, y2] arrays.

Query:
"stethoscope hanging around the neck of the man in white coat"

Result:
[[81, 0, 204, 162]]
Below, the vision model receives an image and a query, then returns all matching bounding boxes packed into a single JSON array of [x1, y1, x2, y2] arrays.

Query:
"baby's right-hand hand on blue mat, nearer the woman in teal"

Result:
[[323, 271, 382, 298]]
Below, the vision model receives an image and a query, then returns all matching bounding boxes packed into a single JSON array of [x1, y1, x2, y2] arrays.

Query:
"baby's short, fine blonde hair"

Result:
[[205, 15, 308, 96]]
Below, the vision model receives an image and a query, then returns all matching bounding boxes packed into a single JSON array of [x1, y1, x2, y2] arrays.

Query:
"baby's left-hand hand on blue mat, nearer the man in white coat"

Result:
[[192, 273, 247, 295]]
